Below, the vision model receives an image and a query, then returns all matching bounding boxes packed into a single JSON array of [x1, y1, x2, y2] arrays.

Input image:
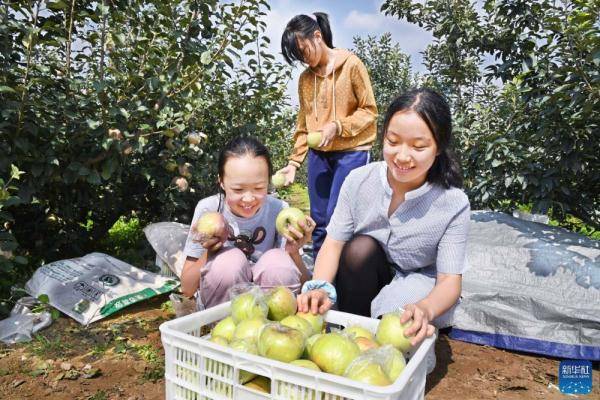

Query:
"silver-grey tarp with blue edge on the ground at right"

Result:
[[450, 211, 600, 360]]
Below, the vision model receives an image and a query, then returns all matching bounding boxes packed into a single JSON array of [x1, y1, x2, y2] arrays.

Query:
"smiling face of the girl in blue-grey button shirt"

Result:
[[383, 111, 438, 191]]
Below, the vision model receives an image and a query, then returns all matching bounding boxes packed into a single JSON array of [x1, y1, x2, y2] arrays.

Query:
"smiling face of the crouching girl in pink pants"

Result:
[[220, 154, 269, 218]]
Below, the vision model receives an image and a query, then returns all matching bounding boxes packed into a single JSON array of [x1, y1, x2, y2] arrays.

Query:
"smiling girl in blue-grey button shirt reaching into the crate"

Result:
[[298, 89, 470, 345]]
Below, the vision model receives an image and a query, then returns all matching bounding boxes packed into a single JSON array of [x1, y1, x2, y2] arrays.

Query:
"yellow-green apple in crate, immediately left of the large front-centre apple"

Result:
[[258, 323, 305, 362]]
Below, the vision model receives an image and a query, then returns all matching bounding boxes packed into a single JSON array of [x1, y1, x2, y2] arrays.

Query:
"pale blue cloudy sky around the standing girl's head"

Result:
[[265, 0, 433, 104]]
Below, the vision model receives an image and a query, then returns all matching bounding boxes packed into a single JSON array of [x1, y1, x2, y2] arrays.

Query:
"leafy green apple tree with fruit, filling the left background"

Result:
[[0, 0, 293, 306]]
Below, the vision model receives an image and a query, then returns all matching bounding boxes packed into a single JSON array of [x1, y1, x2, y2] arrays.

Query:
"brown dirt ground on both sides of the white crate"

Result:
[[0, 296, 600, 400]]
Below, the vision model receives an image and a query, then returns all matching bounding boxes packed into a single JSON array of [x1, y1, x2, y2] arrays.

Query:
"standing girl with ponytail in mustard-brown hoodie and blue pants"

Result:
[[279, 12, 377, 258]]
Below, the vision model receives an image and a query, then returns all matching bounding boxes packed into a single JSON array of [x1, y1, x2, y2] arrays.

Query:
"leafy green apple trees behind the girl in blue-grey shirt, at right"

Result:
[[382, 0, 600, 226]]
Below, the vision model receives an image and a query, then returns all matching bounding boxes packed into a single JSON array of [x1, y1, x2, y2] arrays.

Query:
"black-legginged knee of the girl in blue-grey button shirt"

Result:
[[335, 235, 392, 317]]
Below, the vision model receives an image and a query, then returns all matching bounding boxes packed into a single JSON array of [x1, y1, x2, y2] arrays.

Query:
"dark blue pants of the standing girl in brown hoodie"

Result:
[[308, 149, 369, 259]]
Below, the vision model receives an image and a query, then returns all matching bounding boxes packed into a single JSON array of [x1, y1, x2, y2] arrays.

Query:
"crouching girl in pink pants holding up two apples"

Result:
[[181, 137, 314, 308]]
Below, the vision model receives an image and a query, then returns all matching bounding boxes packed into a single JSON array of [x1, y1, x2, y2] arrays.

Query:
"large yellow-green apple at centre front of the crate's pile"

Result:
[[310, 333, 360, 375]]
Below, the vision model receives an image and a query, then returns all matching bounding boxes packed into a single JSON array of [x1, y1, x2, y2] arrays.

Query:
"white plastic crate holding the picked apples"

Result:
[[160, 302, 435, 400]]
